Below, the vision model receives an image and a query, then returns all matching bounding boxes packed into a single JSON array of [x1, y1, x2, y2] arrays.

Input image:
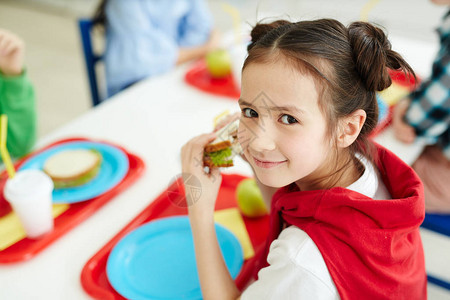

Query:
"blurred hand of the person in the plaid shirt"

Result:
[[392, 98, 416, 144]]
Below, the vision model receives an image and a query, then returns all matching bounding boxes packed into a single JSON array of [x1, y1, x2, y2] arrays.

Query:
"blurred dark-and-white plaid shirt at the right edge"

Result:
[[405, 11, 450, 159]]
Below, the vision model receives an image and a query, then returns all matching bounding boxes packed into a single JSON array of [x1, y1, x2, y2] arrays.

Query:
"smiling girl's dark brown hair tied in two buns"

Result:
[[243, 19, 415, 164]]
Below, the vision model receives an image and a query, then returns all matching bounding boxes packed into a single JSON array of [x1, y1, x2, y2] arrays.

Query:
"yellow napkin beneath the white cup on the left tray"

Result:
[[0, 204, 70, 251]]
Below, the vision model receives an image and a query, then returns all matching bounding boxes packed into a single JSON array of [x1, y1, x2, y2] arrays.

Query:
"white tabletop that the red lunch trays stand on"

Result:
[[0, 34, 436, 300]]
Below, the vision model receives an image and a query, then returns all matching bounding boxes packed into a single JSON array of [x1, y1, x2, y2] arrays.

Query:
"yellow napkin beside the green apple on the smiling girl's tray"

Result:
[[214, 208, 255, 260]]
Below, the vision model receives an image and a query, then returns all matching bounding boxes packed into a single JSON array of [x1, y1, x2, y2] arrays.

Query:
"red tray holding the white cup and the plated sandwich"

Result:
[[0, 138, 145, 263]]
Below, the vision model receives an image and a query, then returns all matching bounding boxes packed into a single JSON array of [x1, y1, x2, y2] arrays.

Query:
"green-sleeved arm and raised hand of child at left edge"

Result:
[[0, 28, 36, 157]]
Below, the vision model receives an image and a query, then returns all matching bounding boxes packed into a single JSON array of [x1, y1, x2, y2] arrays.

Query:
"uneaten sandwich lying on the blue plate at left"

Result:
[[43, 149, 102, 189]]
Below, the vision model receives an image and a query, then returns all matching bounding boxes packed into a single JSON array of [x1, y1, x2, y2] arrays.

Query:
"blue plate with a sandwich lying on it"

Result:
[[19, 142, 129, 203]]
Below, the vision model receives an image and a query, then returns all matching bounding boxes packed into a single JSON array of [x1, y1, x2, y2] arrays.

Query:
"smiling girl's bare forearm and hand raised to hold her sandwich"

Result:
[[181, 133, 240, 299]]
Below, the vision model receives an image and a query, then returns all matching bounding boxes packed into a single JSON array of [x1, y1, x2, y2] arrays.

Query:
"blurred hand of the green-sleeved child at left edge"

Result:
[[0, 28, 25, 76]]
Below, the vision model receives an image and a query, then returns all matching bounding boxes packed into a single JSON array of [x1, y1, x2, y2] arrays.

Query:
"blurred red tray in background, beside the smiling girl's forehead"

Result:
[[184, 59, 241, 101]]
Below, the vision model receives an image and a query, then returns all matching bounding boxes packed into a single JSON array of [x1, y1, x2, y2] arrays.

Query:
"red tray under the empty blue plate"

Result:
[[81, 174, 269, 300]]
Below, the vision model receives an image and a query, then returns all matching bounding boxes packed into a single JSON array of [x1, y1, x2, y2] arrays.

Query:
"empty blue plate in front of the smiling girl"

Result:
[[106, 216, 243, 300]]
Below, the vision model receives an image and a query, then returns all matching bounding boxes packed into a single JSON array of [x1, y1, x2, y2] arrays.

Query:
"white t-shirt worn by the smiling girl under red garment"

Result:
[[241, 155, 391, 300]]
